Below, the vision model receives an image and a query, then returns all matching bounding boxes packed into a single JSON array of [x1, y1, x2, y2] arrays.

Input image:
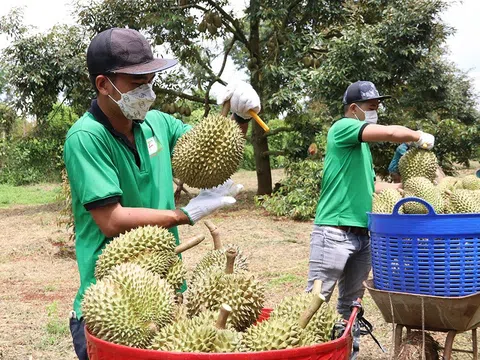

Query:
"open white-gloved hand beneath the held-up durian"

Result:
[[181, 179, 243, 225]]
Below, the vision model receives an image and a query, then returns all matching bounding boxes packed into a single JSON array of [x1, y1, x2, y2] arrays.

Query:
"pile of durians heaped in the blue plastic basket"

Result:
[[372, 149, 480, 214]]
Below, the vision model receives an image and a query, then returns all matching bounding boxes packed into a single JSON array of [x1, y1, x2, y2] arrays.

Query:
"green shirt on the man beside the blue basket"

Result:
[[315, 118, 375, 227]]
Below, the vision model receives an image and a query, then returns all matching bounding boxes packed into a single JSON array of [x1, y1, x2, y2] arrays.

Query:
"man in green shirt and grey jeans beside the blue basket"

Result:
[[307, 81, 435, 318]]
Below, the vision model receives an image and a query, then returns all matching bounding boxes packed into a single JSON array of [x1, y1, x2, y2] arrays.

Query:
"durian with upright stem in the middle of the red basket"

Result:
[[187, 249, 265, 331]]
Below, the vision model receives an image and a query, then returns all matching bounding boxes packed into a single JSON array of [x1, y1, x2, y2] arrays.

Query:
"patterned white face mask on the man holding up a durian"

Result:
[[107, 78, 157, 120]]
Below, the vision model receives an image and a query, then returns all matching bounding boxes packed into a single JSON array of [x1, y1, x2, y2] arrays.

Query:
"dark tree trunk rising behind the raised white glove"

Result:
[[249, 0, 272, 195]]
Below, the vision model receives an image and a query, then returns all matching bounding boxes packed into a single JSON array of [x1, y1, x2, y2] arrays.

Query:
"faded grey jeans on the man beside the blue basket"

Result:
[[306, 225, 372, 319]]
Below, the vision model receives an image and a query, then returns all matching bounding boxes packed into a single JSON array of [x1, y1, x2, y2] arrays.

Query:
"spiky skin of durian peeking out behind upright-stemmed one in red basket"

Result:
[[189, 244, 248, 286]]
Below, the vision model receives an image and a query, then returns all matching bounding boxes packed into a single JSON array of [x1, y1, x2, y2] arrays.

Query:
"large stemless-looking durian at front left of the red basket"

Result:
[[82, 263, 174, 348]]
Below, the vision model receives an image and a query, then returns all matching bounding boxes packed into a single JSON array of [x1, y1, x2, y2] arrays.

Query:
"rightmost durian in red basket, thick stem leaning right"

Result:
[[240, 294, 325, 351]]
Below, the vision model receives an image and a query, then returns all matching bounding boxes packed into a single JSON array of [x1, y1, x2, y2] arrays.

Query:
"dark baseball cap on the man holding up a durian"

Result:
[[87, 28, 177, 75]]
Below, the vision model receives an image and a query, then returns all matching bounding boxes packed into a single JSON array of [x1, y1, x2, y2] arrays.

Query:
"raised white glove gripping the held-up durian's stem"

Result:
[[217, 81, 262, 119]]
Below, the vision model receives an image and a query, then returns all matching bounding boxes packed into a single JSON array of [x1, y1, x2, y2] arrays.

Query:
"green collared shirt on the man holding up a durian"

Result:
[[64, 103, 190, 318]]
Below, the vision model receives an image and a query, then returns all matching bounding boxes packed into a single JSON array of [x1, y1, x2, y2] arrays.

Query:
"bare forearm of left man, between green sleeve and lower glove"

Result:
[[90, 203, 190, 237]]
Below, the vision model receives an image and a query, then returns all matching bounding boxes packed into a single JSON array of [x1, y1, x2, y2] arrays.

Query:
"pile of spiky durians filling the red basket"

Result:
[[82, 221, 339, 353]]
